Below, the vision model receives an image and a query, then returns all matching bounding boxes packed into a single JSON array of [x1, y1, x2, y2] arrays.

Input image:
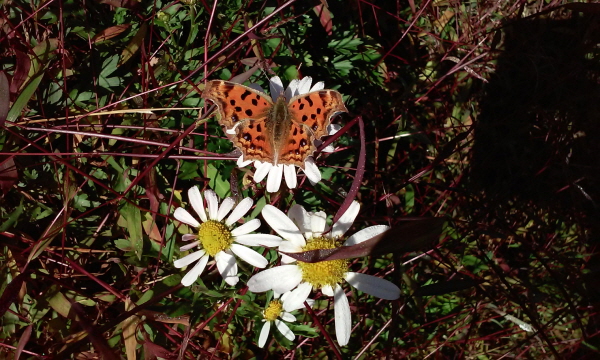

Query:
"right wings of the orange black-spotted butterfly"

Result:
[[278, 90, 348, 169]]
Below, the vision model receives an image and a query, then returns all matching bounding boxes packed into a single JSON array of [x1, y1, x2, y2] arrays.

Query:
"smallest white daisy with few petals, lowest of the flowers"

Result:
[[258, 292, 314, 348]]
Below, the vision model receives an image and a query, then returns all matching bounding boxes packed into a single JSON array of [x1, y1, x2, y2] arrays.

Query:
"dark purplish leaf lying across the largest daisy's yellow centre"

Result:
[[282, 218, 446, 263]]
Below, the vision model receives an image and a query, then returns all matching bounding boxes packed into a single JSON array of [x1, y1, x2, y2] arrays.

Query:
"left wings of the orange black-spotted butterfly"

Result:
[[202, 80, 274, 162]]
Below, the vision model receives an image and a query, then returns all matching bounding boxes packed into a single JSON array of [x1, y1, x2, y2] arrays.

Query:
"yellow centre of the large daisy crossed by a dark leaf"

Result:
[[298, 237, 348, 289]]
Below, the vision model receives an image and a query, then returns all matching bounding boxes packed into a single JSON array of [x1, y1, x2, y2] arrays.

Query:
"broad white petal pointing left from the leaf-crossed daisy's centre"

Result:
[[247, 265, 302, 294]]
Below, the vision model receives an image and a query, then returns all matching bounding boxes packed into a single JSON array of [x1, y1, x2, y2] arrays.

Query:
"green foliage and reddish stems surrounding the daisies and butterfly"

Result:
[[0, 0, 600, 359]]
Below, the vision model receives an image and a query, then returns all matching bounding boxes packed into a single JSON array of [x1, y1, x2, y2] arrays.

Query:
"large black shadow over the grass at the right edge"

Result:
[[471, 9, 600, 217]]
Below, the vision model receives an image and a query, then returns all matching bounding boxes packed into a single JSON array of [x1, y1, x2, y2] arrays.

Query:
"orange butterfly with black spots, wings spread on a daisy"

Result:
[[202, 80, 348, 169]]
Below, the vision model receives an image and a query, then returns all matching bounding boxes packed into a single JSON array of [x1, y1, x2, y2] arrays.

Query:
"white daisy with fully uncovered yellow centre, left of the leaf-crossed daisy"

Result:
[[173, 186, 281, 286]]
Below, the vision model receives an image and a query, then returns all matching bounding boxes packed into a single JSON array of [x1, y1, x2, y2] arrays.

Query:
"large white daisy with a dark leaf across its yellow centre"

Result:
[[248, 201, 400, 346]]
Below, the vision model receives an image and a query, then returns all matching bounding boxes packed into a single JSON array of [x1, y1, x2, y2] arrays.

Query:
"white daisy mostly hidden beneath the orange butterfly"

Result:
[[237, 76, 341, 192]]
